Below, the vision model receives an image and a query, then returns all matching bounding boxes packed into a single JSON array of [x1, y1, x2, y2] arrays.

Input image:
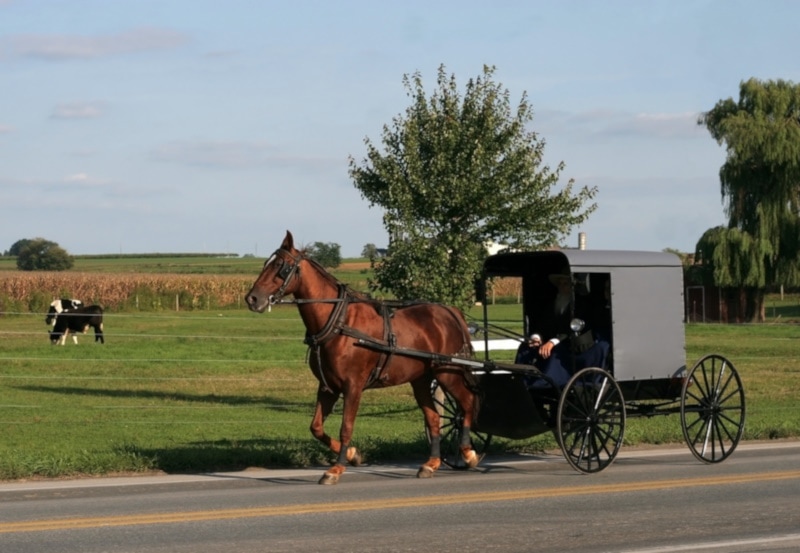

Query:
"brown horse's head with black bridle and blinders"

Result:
[[245, 230, 303, 313]]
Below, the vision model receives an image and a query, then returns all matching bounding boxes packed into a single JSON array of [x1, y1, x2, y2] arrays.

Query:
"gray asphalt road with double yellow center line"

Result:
[[0, 442, 800, 553]]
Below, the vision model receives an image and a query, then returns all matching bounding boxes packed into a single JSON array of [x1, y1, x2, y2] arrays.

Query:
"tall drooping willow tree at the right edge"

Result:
[[697, 79, 800, 320]]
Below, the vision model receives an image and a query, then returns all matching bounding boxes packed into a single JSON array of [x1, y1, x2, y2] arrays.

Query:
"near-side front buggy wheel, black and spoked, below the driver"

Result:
[[556, 367, 625, 473]]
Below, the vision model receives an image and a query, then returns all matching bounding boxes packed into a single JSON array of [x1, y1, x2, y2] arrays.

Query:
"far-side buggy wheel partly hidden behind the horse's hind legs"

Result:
[[425, 380, 492, 470]]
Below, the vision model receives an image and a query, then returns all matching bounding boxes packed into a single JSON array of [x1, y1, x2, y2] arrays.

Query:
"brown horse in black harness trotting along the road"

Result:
[[246, 231, 479, 484]]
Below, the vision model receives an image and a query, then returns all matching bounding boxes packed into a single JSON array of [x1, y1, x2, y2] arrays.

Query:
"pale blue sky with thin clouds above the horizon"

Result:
[[0, 0, 800, 257]]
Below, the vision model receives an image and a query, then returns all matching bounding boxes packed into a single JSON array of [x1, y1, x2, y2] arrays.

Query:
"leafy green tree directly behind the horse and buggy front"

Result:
[[349, 66, 596, 308]]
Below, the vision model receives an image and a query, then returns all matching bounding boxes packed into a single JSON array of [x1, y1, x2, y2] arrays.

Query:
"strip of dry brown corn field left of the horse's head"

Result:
[[0, 271, 254, 313]]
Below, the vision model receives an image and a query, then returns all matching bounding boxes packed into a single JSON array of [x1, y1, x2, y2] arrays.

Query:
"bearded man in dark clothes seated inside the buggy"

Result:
[[532, 267, 610, 388]]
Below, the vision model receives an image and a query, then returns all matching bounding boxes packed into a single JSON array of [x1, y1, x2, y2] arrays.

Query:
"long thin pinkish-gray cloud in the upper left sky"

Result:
[[0, 28, 187, 61]]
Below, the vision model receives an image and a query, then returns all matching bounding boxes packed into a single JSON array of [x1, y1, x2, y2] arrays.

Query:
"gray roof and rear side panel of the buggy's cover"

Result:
[[484, 250, 686, 381]]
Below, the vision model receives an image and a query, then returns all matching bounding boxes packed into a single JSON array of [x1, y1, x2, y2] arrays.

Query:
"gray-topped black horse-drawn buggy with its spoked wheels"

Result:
[[433, 250, 745, 473]]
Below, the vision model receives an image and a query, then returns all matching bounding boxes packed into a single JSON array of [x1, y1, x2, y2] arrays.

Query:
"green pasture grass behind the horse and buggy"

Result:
[[0, 305, 800, 479]]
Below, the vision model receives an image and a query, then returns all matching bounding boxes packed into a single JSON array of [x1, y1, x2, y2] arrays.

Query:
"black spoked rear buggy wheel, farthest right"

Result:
[[681, 354, 745, 463]]
